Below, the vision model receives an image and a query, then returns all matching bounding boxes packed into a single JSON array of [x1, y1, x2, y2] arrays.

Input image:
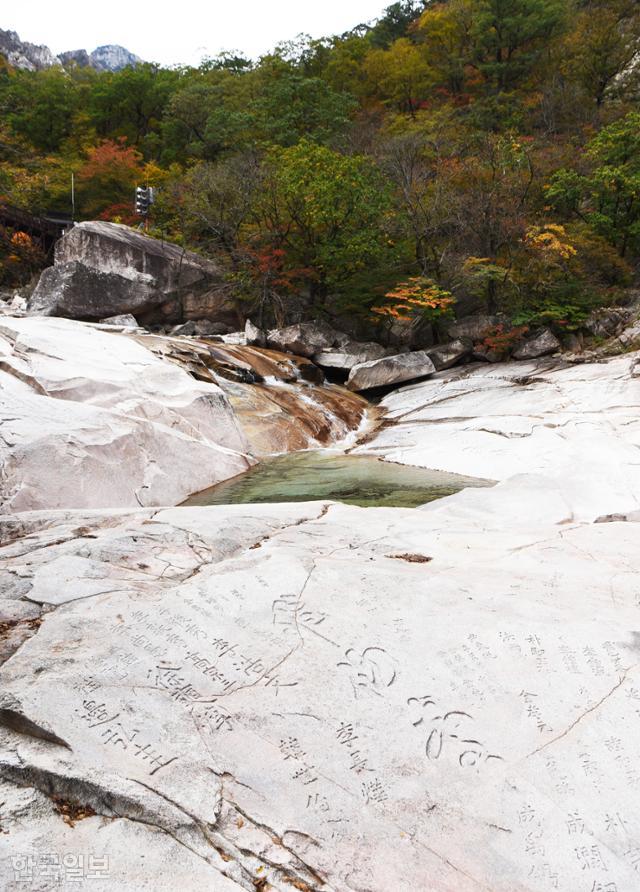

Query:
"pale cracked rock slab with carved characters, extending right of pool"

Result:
[[0, 357, 640, 892]]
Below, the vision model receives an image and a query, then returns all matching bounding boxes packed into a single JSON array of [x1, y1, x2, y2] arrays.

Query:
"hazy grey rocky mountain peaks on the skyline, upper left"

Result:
[[0, 28, 142, 71]]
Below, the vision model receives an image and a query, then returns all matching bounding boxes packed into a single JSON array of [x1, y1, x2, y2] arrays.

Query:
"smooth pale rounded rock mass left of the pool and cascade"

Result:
[[0, 317, 253, 511]]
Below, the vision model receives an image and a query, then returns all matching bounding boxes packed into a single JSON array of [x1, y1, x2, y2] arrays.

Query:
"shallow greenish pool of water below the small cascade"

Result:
[[185, 451, 492, 508]]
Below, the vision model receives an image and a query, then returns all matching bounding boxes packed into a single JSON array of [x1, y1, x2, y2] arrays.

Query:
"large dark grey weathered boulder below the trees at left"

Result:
[[28, 221, 237, 323]]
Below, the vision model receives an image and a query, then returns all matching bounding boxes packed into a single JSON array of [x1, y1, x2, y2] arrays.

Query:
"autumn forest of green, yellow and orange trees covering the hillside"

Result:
[[0, 0, 640, 331]]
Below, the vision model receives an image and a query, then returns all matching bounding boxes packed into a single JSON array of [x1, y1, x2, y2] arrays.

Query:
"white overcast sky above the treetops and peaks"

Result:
[[5, 0, 391, 65]]
